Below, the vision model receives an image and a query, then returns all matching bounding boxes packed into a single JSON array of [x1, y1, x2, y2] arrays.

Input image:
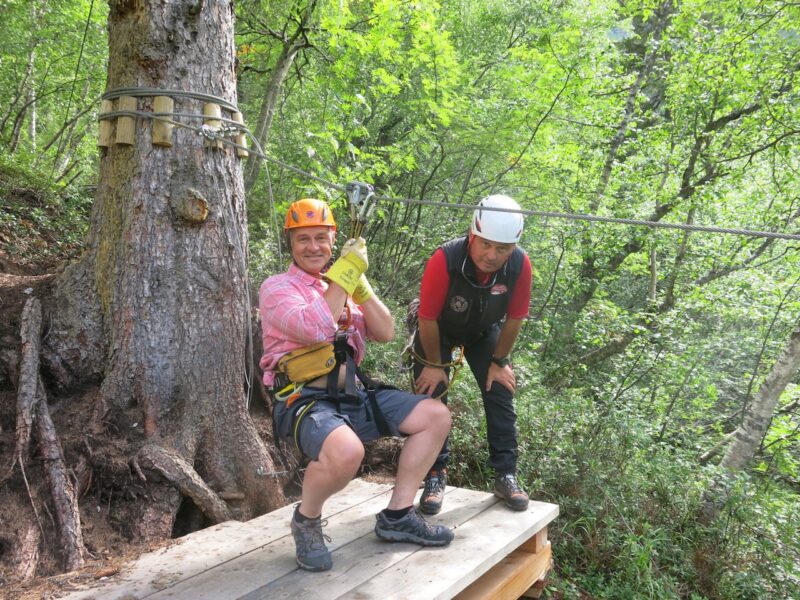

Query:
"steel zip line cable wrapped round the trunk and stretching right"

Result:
[[100, 88, 800, 240]]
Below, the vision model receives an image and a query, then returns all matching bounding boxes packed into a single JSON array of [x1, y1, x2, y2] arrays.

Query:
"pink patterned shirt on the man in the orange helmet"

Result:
[[258, 263, 368, 387]]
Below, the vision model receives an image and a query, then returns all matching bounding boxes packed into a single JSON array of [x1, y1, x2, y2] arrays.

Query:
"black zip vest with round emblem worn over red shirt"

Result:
[[437, 236, 525, 344]]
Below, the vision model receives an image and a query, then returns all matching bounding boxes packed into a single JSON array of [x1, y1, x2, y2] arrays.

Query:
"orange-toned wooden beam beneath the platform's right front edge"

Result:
[[455, 542, 553, 600]]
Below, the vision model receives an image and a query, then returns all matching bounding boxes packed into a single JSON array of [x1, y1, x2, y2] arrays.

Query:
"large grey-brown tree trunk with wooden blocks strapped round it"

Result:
[[44, 0, 284, 538]]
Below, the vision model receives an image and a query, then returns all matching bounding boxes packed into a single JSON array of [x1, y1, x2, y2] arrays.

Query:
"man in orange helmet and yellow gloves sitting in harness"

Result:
[[259, 199, 453, 571]]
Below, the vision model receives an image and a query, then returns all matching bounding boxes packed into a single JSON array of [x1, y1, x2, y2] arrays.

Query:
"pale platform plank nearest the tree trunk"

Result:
[[58, 479, 392, 600]]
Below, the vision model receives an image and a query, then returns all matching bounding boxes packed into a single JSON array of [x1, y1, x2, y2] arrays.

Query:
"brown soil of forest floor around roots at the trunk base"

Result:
[[0, 240, 399, 600]]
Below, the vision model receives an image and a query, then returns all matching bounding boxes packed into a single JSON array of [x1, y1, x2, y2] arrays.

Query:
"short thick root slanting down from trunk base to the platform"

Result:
[[137, 444, 233, 523]]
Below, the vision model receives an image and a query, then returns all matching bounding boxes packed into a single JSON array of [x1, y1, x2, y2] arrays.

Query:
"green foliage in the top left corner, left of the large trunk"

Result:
[[0, 0, 108, 185]]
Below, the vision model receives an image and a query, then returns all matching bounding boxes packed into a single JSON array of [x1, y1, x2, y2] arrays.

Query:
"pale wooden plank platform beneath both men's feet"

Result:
[[65, 479, 558, 600]]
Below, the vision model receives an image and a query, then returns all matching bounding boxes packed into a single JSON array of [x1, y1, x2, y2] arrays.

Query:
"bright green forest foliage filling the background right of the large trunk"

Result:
[[234, 0, 800, 598]]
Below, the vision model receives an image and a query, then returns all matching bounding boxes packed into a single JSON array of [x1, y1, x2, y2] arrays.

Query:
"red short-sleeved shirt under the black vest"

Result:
[[417, 248, 532, 321]]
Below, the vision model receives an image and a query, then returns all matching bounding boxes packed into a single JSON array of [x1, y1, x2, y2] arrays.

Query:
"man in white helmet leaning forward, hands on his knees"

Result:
[[414, 194, 531, 514]]
